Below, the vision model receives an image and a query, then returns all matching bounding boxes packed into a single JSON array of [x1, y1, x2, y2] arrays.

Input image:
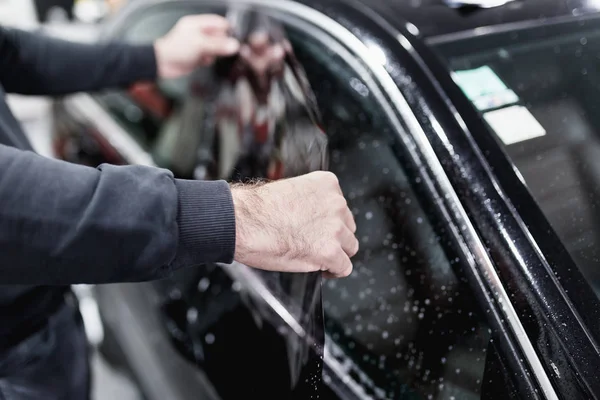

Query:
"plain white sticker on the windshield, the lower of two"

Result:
[[484, 106, 546, 145]]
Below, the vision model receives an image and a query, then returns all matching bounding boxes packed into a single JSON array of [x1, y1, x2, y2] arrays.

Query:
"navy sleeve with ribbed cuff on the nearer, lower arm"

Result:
[[0, 145, 235, 285]]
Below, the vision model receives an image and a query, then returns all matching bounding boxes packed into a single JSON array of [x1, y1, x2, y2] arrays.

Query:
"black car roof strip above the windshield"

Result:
[[356, 0, 600, 38]]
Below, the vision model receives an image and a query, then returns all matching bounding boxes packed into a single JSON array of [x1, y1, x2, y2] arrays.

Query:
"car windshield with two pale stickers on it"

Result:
[[437, 18, 600, 300]]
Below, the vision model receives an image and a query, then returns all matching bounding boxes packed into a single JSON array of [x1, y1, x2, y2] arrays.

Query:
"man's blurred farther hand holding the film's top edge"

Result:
[[154, 14, 240, 78]]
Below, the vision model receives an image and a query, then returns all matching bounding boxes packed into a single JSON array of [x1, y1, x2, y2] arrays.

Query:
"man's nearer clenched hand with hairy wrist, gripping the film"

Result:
[[231, 172, 358, 277]]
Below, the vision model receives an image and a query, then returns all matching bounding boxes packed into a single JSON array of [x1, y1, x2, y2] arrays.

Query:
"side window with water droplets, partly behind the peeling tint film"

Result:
[[99, 6, 502, 400]]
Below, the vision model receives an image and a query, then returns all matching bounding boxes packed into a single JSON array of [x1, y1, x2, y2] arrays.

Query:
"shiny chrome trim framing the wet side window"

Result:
[[75, 0, 558, 400]]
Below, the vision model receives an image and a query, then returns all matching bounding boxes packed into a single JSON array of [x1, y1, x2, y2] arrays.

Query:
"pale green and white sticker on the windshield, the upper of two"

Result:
[[453, 65, 519, 111]]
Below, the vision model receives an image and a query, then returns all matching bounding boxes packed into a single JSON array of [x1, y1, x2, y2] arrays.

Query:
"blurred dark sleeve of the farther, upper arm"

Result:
[[0, 27, 157, 95]]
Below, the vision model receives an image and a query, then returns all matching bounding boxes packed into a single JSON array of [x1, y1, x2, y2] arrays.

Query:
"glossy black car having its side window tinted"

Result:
[[54, 0, 600, 400]]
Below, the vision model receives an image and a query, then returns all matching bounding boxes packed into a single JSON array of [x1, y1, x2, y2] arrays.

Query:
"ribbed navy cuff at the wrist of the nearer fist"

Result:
[[175, 179, 235, 266]]
